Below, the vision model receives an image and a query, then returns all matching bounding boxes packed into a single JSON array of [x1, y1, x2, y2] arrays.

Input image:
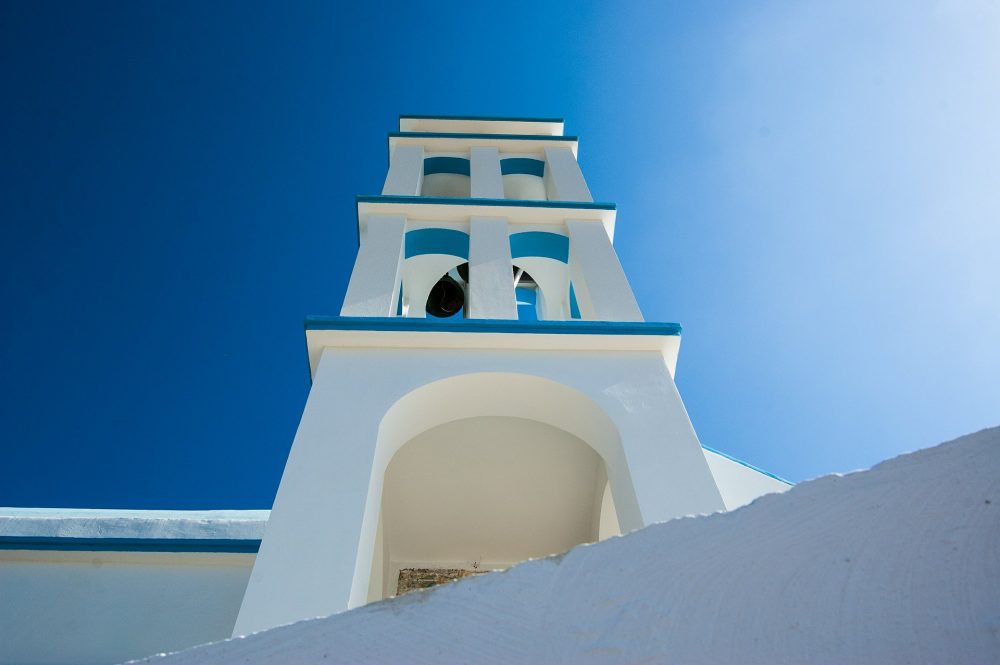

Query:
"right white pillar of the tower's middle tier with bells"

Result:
[[566, 220, 643, 321]]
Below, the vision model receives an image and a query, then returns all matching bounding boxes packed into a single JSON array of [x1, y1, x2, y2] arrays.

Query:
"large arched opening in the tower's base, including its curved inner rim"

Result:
[[351, 372, 642, 606]]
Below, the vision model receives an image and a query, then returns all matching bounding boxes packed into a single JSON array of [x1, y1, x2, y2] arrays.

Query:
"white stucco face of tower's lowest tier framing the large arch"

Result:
[[235, 348, 724, 634]]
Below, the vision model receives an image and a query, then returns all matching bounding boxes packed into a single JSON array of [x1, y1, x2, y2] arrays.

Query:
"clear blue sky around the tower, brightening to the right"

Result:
[[0, 1, 1000, 508]]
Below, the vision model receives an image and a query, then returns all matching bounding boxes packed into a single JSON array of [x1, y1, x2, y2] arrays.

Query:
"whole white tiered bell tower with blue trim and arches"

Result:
[[234, 116, 780, 635]]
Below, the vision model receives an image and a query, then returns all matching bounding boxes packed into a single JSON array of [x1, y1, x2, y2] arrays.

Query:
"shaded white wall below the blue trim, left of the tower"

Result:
[[0, 550, 254, 665]]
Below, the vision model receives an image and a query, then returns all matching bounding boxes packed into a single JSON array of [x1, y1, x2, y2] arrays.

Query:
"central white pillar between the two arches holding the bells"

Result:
[[469, 218, 517, 319]]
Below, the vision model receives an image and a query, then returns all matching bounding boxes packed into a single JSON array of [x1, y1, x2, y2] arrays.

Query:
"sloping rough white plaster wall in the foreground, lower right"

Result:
[[143, 428, 1000, 665]]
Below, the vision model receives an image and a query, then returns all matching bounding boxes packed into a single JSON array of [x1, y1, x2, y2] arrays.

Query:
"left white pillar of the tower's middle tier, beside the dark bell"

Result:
[[340, 215, 406, 316]]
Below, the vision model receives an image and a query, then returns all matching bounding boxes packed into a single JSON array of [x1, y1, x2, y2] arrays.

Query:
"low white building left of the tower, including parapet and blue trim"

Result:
[[0, 508, 268, 665]]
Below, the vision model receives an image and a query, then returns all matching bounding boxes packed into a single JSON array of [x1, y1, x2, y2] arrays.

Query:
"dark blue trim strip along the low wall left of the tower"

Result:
[[0, 536, 260, 554]]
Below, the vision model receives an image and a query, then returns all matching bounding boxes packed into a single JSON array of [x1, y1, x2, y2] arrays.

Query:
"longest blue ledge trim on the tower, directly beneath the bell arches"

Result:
[[305, 316, 681, 337]]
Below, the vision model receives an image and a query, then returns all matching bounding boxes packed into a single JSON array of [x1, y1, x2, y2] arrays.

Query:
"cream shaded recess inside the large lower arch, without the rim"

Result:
[[376, 416, 617, 597]]
